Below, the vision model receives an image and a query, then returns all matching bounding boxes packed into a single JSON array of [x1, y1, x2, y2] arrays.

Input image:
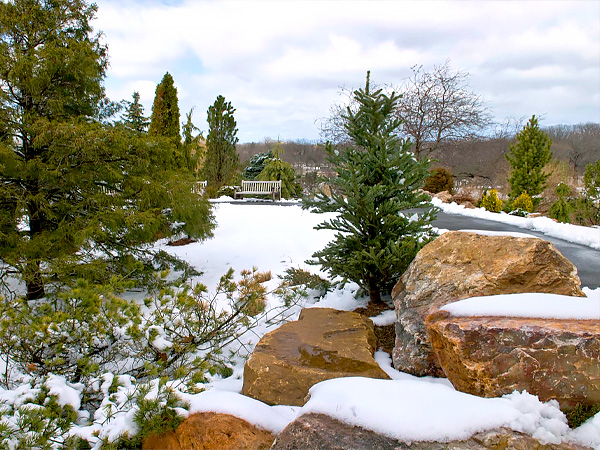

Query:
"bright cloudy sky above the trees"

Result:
[[94, 0, 600, 142]]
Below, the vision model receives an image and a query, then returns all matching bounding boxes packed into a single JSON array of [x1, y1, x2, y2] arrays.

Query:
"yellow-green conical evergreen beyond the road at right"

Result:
[[506, 115, 552, 199]]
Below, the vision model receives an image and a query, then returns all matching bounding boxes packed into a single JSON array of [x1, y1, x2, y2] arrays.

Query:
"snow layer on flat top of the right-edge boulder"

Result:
[[441, 293, 600, 320]]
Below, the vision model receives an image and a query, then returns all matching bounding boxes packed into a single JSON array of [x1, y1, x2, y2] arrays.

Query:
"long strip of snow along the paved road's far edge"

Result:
[[432, 198, 600, 249]]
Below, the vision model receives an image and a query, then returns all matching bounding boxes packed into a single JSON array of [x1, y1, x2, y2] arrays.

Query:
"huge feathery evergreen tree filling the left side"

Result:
[[0, 0, 214, 304]]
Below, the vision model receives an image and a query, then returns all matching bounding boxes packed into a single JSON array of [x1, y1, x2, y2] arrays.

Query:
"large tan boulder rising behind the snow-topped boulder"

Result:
[[392, 231, 585, 377]]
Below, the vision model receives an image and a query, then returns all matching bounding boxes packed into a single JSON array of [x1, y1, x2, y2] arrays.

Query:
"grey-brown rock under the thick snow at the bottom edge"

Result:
[[271, 414, 589, 450]]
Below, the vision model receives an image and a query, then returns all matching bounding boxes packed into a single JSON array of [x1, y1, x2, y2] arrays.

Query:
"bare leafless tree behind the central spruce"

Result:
[[396, 61, 491, 158]]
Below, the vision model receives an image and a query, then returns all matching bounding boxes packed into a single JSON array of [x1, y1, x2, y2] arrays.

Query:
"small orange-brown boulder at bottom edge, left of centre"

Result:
[[142, 412, 275, 450]]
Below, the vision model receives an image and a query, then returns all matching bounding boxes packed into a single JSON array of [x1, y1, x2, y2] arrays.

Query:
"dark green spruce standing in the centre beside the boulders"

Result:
[[303, 74, 434, 303]]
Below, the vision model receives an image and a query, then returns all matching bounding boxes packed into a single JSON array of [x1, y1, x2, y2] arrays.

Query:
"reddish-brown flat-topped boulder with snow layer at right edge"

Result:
[[426, 311, 600, 411]]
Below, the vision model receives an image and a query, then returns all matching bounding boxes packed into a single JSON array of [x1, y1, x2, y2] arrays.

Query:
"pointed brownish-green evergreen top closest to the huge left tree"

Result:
[[148, 72, 181, 145]]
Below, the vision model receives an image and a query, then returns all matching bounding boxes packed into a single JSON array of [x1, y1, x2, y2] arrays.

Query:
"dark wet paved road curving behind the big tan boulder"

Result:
[[433, 211, 600, 289]]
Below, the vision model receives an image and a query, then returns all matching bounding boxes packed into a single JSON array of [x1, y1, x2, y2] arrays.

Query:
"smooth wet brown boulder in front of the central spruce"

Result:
[[242, 308, 389, 406]]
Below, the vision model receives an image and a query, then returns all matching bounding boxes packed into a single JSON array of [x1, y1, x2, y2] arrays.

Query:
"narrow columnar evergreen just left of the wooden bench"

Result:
[[203, 95, 239, 196]]
